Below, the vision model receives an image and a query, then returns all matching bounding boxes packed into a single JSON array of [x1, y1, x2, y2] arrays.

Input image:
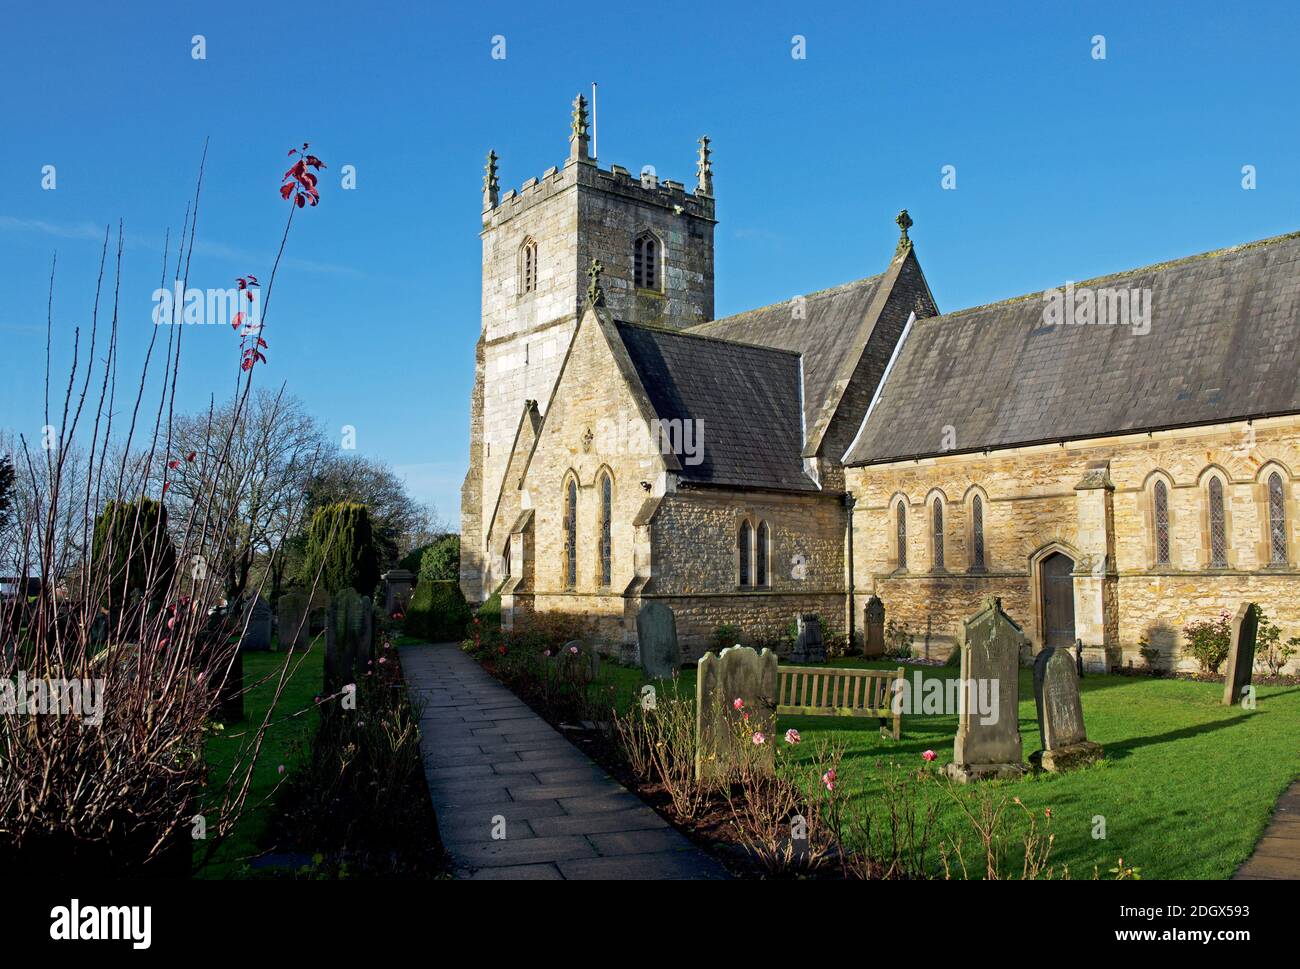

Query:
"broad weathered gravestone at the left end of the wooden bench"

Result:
[[696, 646, 777, 782]]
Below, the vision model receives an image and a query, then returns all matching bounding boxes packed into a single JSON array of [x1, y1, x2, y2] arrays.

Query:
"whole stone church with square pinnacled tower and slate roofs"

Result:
[[462, 96, 1300, 666]]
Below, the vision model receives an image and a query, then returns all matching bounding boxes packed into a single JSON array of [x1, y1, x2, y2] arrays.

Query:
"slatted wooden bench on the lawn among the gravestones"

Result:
[[776, 666, 904, 740]]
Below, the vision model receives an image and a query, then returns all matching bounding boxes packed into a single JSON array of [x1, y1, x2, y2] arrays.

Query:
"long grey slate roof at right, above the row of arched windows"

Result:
[[845, 233, 1300, 464]]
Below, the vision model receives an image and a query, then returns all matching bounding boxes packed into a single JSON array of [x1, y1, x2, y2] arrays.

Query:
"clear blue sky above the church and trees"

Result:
[[0, 0, 1300, 523]]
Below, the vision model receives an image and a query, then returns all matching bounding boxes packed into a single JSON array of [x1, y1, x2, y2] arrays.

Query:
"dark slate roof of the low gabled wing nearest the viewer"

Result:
[[615, 321, 818, 492]]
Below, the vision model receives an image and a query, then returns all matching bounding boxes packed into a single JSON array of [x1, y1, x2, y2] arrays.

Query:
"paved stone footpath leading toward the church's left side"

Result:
[[402, 644, 727, 879]]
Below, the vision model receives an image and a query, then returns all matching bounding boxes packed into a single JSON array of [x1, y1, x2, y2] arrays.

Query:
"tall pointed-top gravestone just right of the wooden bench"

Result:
[[944, 598, 1026, 783]]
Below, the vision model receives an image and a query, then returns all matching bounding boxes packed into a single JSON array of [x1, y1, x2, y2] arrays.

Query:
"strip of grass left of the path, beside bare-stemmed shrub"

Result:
[[195, 635, 325, 878]]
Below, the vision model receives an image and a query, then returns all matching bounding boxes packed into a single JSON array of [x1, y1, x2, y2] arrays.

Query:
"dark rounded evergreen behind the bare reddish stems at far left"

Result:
[[92, 498, 176, 617]]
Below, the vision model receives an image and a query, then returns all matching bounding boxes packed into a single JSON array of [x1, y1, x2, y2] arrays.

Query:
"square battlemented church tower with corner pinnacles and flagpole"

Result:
[[460, 95, 715, 602]]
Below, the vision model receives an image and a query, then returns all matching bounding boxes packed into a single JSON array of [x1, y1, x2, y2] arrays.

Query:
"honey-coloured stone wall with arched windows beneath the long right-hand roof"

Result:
[[848, 418, 1300, 669]]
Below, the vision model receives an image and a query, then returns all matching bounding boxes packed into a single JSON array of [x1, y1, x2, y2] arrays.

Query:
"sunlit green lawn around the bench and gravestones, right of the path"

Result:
[[601, 659, 1300, 879]]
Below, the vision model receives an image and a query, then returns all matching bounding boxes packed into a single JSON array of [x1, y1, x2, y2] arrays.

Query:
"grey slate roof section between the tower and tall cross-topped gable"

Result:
[[688, 273, 885, 437]]
